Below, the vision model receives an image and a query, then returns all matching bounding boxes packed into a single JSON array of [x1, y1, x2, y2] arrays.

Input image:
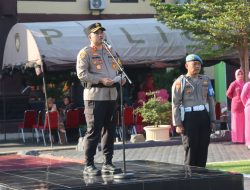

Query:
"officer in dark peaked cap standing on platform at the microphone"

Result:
[[76, 23, 126, 175]]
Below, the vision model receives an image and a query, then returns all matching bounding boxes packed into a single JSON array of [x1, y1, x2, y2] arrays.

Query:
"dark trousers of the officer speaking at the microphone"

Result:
[[84, 101, 116, 165]]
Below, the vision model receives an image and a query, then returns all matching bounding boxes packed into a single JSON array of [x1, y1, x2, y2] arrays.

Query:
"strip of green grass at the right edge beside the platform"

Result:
[[206, 160, 250, 174]]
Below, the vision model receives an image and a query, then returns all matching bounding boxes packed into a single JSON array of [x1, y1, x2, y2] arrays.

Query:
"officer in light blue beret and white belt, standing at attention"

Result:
[[172, 54, 215, 167]]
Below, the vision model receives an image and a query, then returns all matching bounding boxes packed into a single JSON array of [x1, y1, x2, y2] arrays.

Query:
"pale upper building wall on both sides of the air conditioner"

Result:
[[17, 0, 175, 14]]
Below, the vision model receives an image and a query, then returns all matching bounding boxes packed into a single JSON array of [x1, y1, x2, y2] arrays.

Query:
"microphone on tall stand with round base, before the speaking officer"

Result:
[[103, 41, 134, 179]]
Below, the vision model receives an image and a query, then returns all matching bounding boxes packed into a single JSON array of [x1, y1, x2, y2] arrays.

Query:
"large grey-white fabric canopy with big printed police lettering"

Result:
[[3, 19, 195, 71]]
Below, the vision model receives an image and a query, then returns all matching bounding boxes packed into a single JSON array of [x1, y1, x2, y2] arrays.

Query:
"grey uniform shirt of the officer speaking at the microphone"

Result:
[[76, 46, 118, 100]]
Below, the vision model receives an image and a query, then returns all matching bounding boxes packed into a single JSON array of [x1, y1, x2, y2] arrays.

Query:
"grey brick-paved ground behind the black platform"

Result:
[[0, 137, 250, 190]]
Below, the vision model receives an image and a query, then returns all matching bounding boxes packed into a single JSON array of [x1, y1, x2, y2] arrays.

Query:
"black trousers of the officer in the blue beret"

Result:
[[182, 110, 211, 167]]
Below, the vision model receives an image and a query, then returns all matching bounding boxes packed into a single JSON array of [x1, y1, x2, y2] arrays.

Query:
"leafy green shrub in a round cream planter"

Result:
[[135, 91, 172, 141]]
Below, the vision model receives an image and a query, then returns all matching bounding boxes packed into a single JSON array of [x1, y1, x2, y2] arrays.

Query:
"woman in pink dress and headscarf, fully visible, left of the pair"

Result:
[[227, 69, 245, 143]]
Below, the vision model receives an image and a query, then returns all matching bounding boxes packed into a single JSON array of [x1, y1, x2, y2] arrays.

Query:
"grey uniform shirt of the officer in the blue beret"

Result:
[[172, 75, 215, 126]]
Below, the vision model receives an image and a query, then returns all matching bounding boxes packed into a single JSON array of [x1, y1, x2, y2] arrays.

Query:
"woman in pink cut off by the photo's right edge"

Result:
[[240, 72, 250, 149]]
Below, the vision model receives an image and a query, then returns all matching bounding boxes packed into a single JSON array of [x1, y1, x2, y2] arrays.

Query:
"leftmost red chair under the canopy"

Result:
[[18, 110, 36, 143]]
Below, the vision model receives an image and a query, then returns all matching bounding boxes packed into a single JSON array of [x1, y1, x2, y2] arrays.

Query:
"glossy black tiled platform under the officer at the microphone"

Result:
[[0, 155, 243, 190]]
